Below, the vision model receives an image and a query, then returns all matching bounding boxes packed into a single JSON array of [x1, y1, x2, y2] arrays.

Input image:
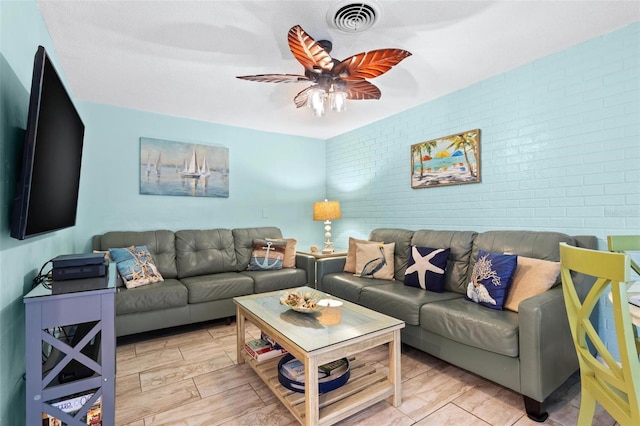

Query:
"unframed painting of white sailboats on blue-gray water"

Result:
[[140, 137, 229, 198]]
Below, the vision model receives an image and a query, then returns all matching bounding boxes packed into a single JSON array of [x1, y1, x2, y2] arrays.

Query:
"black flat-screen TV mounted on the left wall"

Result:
[[11, 46, 84, 240]]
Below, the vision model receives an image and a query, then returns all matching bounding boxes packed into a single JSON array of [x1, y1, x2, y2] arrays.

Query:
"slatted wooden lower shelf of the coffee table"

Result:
[[244, 354, 394, 424]]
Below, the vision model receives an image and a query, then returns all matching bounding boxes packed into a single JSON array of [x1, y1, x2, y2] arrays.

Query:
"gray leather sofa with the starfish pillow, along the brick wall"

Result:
[[316, 229, 597, 421]]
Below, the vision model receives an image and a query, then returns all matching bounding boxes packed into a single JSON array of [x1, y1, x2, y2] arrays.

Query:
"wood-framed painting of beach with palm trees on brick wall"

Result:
[[411, 129, 480, 188]]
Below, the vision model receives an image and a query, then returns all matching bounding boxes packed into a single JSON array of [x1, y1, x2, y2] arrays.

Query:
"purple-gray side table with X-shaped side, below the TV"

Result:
[[23, 264, 116, 426]]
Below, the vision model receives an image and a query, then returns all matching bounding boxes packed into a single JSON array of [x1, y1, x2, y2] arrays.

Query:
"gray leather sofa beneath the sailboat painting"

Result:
[[93, 227, 315, 336]]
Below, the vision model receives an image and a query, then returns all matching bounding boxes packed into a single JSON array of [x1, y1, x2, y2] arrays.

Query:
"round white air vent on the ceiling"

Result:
[[327, 0, 382, 33]]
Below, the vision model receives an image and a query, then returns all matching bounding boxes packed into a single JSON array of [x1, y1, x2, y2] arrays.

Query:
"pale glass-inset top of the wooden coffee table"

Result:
[[233, 287, 404, 352]]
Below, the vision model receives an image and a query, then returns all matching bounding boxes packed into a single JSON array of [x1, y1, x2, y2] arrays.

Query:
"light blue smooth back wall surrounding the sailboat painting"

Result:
[[76, 103, 326, 249]]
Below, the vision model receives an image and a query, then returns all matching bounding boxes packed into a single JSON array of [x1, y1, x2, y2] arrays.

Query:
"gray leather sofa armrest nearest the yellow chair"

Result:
[[519, 286, 578, 402]]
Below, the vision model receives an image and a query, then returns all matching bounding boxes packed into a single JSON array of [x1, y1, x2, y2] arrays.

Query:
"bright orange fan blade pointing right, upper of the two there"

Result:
[[333, 49, 411, 81]]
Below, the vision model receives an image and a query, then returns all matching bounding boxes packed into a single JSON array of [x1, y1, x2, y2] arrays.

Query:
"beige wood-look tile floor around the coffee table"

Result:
[[116, 321, 616, 426]]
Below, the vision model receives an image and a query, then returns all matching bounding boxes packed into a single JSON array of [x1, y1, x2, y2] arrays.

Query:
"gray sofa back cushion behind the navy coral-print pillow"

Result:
[[467, 231, 576, 284]]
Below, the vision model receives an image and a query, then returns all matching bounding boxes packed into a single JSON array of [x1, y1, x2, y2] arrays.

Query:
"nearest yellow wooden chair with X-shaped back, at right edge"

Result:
[[560, 243, 640, 426]]
